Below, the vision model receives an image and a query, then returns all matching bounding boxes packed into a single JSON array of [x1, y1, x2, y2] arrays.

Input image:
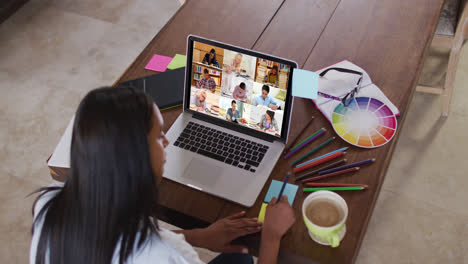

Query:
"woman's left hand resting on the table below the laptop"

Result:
[[188, 212, 262, 254]]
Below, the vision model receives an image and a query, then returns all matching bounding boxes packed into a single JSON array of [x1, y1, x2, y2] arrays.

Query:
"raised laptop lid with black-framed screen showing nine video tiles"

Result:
[[183, 35, 297, 143]]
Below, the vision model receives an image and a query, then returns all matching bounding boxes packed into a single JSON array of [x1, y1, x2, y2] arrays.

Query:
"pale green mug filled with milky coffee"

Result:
[[302, 191, 348, 247]]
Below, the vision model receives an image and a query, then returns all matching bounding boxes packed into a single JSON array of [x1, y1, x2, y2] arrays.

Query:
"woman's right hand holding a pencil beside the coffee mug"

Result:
[[262, 195, 296, 240]]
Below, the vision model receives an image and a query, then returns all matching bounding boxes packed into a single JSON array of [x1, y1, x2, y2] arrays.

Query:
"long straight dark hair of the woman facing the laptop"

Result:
[[32, 87, 159, 264]]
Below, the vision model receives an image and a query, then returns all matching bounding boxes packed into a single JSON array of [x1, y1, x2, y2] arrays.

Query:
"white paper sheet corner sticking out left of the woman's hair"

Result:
[[47, 116, 75, 168]]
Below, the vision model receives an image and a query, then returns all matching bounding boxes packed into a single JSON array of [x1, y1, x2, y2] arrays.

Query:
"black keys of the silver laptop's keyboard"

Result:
[[174, 122, 268, 172]]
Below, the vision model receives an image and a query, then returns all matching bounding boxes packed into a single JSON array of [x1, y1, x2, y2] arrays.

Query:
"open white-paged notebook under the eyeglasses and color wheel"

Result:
[[312, 60, 400, 123]]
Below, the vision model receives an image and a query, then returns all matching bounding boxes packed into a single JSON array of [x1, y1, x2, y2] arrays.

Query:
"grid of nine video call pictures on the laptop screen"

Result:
[[188, 41, 290, 137]]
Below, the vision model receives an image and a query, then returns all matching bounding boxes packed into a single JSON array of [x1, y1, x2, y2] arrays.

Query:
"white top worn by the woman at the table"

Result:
[[29, 186, 203, 264]]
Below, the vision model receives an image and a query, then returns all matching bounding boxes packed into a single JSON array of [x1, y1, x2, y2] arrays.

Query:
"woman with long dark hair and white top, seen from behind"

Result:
[[30, 87, 294, 264]]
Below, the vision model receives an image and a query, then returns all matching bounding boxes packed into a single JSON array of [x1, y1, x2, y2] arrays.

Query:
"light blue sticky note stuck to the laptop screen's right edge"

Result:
[[292, 69, 319, 99]]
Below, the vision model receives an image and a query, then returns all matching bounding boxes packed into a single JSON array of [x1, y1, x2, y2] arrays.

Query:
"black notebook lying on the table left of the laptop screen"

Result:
[[119, 67, 185, 110]]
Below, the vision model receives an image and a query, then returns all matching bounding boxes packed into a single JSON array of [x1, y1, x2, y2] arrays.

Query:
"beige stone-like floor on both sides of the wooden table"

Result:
[[0, 0, 468, 264]]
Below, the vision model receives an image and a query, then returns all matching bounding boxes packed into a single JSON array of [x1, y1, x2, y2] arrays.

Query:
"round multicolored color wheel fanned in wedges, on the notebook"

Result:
[[332, 97, 397, 148]]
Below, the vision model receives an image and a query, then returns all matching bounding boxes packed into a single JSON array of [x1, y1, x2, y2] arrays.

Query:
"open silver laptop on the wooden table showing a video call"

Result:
[[164, 35, 297, 207]]
